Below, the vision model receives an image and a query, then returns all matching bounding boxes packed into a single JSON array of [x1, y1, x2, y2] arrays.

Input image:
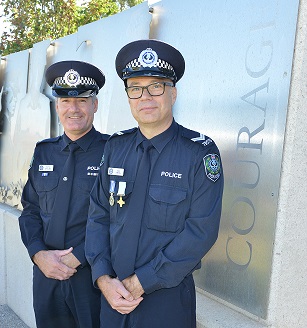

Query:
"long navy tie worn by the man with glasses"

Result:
[[113, 140, 152, 280]]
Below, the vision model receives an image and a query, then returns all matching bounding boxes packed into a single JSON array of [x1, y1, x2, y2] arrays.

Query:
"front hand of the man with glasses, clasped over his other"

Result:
[[97, 275, 143, 314]]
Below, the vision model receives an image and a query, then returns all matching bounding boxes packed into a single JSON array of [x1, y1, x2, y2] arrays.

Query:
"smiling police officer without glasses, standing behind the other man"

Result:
[[19, 61, 108, 328]]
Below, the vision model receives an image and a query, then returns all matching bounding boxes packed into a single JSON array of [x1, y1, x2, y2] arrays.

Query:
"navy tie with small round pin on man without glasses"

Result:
[[45, 142, 79, 249]]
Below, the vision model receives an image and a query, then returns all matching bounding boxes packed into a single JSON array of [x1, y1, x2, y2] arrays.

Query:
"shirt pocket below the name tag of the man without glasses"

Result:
[[36, 176, 59, 214]]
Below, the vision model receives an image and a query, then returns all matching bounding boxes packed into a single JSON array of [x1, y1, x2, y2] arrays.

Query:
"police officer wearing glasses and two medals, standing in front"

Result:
[[85, 40, 223, 328]]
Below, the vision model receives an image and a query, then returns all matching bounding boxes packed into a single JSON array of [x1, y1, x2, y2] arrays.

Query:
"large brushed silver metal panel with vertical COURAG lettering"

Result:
[[151, 0, 299, 318]]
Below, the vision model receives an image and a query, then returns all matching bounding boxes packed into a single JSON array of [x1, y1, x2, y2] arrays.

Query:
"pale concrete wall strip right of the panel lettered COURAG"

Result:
[[268, 1, 307, 328]]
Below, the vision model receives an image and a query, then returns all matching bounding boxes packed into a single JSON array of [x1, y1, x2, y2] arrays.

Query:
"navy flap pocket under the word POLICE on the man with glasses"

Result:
[[145, 185, 187, 232]]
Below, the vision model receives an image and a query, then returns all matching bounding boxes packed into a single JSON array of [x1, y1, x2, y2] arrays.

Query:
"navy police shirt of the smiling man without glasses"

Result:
[[19, 128, 108, 265]]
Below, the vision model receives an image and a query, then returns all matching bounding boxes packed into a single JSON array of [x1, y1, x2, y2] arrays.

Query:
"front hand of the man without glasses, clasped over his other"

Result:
[[32, 247, 77, 280]]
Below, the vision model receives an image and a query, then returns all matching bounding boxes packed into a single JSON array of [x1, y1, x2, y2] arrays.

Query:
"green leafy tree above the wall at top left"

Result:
[[0, 0, 143, 55]]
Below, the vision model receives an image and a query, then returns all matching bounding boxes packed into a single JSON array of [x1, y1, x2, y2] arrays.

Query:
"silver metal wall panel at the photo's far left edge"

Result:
[[0, 50, 29, 206]]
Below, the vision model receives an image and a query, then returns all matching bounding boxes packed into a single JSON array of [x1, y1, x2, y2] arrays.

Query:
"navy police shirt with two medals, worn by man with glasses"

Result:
[[85, 121, 223, 293]]
